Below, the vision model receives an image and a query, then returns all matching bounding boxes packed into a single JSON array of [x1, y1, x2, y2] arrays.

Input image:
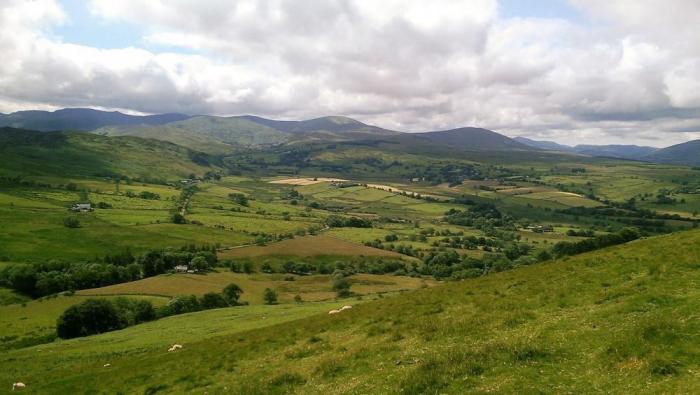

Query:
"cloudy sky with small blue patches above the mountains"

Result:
[[0, 0, 700, 147]]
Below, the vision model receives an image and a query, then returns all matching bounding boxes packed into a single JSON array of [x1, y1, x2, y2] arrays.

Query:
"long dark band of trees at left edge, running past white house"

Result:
[[0, 246, 217, 297]]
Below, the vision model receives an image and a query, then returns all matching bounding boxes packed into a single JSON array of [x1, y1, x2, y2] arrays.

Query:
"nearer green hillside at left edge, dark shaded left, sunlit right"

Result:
[[0, 128, 213, 180]]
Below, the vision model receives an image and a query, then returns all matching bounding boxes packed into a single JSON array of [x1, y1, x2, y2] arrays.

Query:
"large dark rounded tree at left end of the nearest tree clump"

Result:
[[56, 299, 126, 339]]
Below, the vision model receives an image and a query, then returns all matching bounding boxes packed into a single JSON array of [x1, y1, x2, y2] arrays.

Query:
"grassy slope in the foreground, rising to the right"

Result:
[[0, 231, 700, 393]]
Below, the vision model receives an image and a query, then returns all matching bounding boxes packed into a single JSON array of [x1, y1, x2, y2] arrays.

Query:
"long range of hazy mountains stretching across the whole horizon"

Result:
[[0, 108, 700, 165]]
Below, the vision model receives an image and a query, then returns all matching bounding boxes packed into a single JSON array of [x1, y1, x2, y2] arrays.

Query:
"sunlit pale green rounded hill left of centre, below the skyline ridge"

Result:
[[94, 116, 289, 154]]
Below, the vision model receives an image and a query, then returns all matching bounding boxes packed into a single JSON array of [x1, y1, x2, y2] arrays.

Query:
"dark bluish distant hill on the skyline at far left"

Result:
[[0, 108, 189, 132]]
